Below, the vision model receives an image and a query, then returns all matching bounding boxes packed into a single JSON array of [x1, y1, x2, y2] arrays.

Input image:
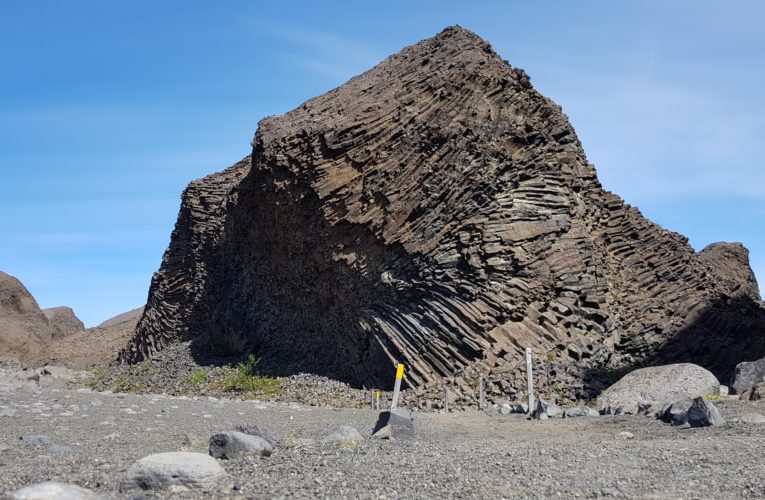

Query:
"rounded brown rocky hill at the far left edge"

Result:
[[0, 271, 53, 365]]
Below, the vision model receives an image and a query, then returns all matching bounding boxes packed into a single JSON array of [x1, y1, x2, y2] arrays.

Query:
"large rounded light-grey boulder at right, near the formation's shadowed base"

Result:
[[598, 363, 720, 415]]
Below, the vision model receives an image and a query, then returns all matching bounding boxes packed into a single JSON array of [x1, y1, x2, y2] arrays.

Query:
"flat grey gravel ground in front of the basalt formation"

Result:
[[0, 370, 765, 498]]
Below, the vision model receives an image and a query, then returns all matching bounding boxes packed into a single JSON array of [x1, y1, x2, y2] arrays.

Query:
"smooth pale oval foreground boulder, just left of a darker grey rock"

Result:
[[120, 451, 226, 491]]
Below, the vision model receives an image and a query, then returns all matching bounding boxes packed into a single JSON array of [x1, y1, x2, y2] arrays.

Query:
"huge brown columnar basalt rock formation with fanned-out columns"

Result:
[[121, 27, 765, 397]]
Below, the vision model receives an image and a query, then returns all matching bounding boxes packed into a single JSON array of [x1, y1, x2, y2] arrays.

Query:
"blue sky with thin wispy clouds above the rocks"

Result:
[[0, 0, 765, 326]]
